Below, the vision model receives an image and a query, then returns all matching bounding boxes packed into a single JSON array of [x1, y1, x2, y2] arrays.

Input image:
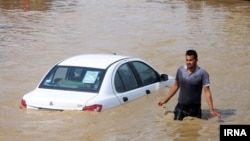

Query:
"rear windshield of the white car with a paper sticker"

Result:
[[39, 66, 105, 93]]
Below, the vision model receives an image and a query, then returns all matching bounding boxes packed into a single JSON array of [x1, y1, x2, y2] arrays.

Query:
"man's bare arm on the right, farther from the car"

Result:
[[203, 86, 221, 118]]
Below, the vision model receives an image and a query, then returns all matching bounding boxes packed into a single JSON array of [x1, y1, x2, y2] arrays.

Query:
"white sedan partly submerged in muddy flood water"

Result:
[[20, 54, 175, 112]]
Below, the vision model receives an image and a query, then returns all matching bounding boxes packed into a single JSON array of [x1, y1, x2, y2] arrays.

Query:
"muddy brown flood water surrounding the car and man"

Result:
[[0, 0, 250, 141]]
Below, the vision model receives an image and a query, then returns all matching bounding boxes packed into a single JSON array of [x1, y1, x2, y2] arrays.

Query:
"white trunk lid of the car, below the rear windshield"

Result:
[[23, 88, 98, 110]]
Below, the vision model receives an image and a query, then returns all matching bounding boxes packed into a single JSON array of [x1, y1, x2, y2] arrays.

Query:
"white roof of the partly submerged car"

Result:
[[58, 54, 132, 69]]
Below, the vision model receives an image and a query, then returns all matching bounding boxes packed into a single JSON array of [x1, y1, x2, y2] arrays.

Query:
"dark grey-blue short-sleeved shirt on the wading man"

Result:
[[176, 66, 210, 106]]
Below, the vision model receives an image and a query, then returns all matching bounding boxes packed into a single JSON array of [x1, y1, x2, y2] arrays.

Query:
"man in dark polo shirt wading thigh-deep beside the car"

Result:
[[158, 50, 221, 120]]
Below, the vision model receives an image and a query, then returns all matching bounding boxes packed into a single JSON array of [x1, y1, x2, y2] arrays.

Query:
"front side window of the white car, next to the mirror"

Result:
[[132, 61, 159, 86]]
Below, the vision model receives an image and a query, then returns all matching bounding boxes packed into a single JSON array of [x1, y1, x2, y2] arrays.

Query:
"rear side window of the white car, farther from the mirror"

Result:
[[115, 64, 138, 92]]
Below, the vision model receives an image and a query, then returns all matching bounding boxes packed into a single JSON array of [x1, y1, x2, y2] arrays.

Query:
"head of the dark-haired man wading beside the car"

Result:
[[186, 50, 198, 69]]
